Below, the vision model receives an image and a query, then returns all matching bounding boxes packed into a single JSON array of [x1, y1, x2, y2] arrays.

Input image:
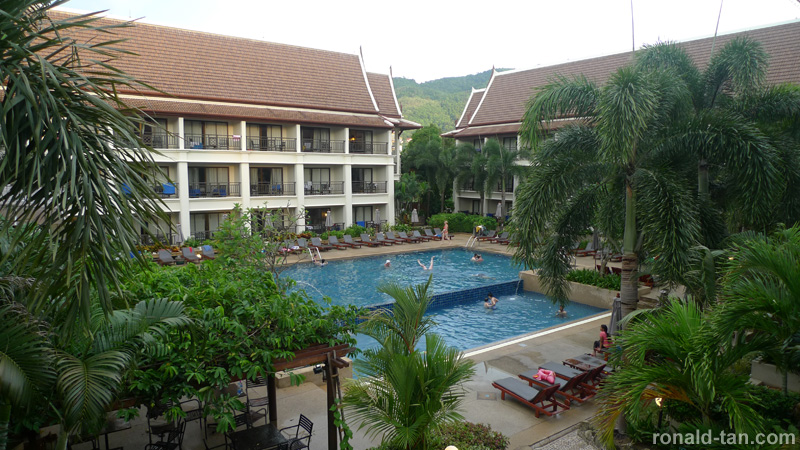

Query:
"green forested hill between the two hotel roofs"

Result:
[[394, 69, 507, 131]]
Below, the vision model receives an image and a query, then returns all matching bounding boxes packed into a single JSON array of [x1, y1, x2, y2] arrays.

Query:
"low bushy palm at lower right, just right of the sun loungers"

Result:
[[595, 299, 764, 445]]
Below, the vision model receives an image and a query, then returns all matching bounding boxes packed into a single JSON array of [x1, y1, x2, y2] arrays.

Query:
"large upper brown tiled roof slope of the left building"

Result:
[[51, 11, 388, 114]]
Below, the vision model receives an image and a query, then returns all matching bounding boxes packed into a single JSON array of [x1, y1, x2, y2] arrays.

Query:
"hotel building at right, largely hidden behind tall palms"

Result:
[[442, 22, 800, 214]]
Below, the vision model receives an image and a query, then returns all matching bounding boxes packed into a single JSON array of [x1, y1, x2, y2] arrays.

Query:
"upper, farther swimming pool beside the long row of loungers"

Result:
[[281, 249, 521, 306]]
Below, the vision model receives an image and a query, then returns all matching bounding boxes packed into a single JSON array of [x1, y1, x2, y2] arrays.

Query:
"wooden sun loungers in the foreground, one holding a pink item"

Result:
[[492, 355, 607, 417]]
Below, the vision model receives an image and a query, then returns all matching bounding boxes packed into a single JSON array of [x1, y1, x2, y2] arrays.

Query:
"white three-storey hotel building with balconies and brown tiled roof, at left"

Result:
[[54, 12, 420, 243]]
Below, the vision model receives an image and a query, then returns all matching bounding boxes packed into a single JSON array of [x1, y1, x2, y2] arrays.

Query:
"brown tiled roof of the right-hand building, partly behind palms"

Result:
[[461, 22, 800, 126]]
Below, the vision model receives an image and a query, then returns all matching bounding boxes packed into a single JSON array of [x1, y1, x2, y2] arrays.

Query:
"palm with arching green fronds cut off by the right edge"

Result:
[[717, 229, 800, 394]]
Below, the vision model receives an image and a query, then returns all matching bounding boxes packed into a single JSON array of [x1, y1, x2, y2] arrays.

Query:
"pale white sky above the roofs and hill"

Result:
[[59, 0, 800, 82]]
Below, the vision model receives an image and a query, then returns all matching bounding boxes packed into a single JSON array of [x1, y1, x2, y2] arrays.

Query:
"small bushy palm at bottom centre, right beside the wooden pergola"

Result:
[[344, 277, 474, 450]]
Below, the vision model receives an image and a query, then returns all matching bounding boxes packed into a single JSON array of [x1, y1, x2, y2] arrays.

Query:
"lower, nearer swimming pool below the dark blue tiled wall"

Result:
[[356, 291, 605, 351]]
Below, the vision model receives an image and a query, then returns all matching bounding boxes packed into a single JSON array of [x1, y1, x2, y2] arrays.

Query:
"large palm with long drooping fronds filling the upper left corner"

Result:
[[0, 0, 169, 323]]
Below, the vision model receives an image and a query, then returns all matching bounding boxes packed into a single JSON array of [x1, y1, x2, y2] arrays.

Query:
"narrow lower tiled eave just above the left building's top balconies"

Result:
[[124, 97, 392, 128]]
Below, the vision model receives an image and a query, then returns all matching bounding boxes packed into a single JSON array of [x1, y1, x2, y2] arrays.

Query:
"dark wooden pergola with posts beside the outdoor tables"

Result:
[[267, 344, 353, 450]]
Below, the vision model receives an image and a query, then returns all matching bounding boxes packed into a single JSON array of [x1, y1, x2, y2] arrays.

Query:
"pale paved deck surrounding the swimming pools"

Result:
[[61, 233, 609, 450]]
